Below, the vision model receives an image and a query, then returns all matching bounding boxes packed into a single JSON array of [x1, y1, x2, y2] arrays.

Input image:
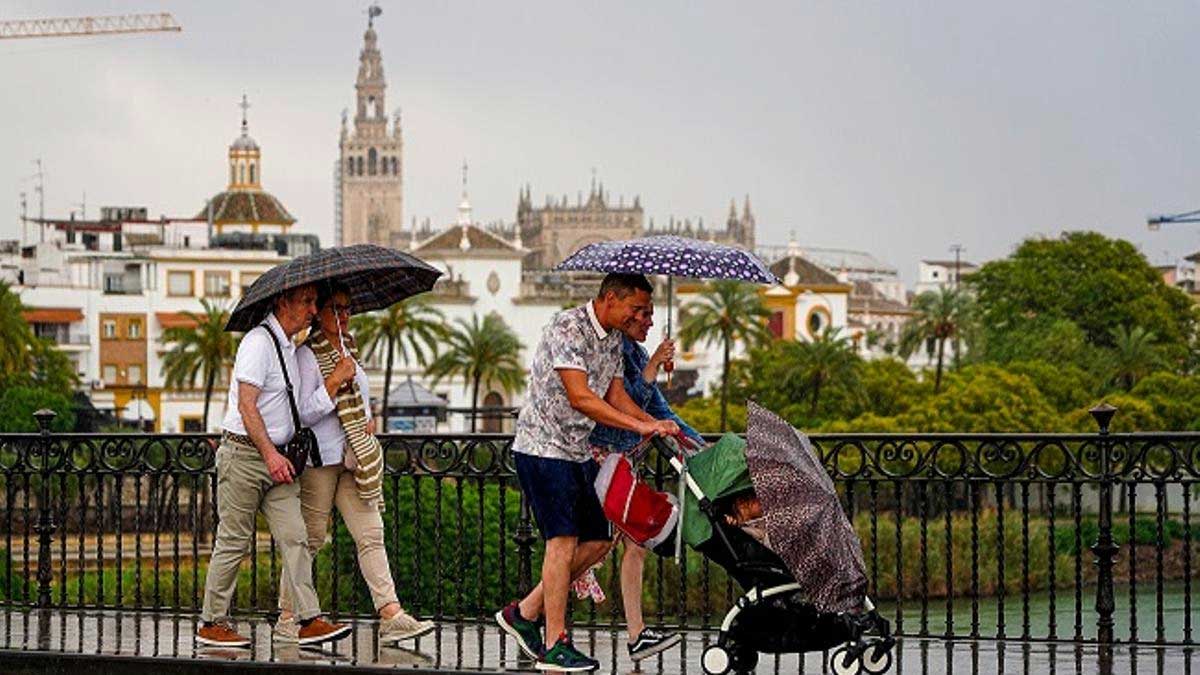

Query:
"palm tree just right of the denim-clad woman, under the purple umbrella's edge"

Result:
[[679, 281, 770, 432]]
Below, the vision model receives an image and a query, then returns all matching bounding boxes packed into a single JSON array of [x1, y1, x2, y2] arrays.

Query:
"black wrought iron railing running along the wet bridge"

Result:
[[0, 403, 1200, 645]]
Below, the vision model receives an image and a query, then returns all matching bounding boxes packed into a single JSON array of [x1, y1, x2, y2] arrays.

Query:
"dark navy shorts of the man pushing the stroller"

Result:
[[512, 453, 612, 542]]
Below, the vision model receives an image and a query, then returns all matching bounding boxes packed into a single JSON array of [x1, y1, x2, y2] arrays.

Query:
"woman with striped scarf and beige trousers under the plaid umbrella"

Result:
[[275, 282, 434, 645]]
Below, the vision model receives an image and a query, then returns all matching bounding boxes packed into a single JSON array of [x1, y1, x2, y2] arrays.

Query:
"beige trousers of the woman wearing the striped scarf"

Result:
[[280, 464, 400, 615]]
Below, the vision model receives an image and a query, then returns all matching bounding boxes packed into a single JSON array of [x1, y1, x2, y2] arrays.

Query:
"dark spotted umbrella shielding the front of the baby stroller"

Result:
[[746, 401, 866, 611]]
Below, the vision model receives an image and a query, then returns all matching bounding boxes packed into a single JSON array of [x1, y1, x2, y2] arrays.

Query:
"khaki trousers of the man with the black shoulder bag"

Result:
[[200, 441, 320, 621]]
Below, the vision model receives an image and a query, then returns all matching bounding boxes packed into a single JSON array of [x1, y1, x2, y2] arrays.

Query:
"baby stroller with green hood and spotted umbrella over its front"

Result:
[[655, 402, 895, 675]]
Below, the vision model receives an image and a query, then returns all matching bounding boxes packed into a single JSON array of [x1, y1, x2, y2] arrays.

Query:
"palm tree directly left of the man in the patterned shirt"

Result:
[[428, 313, 526, 432]]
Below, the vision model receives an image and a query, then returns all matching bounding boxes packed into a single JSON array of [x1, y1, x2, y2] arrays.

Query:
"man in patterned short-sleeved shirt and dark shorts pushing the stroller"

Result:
[[496, 274, 679, 673]]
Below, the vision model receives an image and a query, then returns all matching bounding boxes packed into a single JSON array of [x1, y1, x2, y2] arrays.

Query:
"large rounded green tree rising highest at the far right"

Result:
[[965, 232, 1196, 364]]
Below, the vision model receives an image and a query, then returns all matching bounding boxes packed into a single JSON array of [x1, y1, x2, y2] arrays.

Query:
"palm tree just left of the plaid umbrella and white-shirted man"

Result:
[[162, 298, 238, 430]]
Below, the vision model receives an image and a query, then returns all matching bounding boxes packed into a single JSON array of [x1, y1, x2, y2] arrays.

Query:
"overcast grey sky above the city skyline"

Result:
[[0, 0, 1200, 281]]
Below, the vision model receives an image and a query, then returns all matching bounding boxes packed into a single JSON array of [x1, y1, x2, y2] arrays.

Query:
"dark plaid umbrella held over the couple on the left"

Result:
[[226, 244, 442, 331]]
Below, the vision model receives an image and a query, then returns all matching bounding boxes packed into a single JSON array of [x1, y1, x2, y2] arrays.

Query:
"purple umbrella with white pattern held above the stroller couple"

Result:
[[554, 234, 780, 336]]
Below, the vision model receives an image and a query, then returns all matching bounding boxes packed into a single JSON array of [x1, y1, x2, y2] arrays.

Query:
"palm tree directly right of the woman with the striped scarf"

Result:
[[350, 298, 445, 431]]
